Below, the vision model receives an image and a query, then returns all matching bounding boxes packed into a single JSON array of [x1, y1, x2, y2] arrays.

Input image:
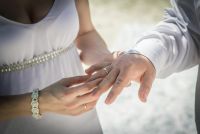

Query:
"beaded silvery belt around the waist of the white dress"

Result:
[[0, 45, 73, 73]]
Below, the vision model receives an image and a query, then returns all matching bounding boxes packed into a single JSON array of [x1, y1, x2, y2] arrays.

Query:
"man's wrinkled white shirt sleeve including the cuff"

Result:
[[129, 4, 199, 78]]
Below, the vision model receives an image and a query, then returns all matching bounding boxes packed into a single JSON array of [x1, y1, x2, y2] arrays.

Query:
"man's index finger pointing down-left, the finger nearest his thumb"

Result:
[[105, 71, 130, 104]]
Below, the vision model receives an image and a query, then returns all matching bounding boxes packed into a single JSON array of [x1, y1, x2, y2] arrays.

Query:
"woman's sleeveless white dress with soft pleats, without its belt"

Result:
[[0, 0, 102, 134]]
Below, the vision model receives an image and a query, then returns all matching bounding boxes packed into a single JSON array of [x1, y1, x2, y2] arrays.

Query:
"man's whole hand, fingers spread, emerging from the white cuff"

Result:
[[86, 54, 155, 104]]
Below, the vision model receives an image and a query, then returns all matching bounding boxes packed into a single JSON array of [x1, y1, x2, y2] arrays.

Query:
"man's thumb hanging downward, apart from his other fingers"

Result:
[[138, 73, 154, 102]]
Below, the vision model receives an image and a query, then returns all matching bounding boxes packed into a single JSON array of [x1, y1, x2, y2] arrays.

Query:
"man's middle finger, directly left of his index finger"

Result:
[[93, 69, 119, 96]]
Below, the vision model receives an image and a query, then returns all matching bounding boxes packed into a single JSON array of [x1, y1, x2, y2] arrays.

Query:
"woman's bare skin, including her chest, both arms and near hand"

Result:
[[0, 0, 112, 120]]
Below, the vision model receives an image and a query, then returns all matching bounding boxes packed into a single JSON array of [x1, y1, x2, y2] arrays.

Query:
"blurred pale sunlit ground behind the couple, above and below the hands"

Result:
[[90, 0, 197, 134]]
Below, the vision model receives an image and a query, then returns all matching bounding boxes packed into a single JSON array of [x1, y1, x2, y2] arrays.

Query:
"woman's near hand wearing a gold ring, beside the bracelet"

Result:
[[39, 76, 102, 115]]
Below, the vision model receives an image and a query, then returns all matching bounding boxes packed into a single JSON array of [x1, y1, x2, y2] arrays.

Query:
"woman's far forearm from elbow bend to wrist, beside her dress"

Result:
[[76, 30, 112, 65]]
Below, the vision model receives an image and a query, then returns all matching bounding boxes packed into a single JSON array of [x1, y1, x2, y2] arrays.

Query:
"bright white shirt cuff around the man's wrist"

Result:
[[127, 38, 167, 75]]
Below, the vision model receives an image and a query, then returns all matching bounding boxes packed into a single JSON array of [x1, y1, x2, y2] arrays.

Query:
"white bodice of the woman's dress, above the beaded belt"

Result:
[[0, 0, 79, 65]]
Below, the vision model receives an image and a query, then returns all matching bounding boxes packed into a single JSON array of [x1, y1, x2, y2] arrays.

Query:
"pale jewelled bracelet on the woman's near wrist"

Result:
[[31, 89, 42, 119]]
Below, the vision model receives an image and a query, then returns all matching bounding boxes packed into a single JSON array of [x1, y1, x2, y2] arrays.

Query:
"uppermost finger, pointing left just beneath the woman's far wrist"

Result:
[[85, 62, 111, 74]]
